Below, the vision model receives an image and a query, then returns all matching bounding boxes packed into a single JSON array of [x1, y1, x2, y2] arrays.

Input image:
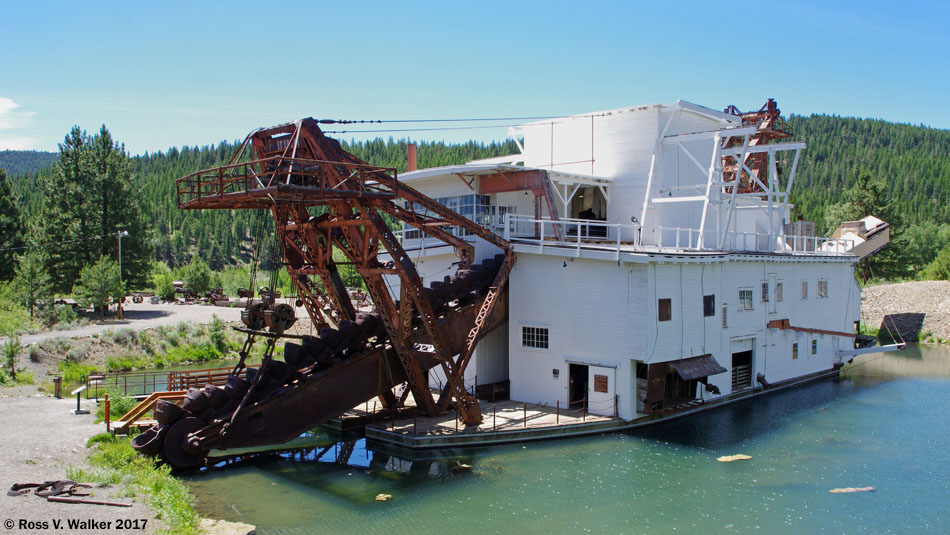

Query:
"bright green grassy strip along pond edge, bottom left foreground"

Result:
[[66, 433, 200, 535]]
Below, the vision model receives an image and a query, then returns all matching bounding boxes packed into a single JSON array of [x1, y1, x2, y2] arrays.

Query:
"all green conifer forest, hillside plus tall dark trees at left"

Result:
[[0, 115, 950, 302]]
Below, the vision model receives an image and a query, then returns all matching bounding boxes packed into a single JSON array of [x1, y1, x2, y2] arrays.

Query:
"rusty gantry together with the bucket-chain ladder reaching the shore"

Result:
[[133, 118, 514, 468]]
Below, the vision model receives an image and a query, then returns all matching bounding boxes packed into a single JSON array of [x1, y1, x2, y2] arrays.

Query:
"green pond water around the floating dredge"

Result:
[[188, 347, 950, 534]]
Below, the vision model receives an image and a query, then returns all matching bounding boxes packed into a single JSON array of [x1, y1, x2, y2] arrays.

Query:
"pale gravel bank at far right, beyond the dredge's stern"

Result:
[[861, 281, 950, 340]]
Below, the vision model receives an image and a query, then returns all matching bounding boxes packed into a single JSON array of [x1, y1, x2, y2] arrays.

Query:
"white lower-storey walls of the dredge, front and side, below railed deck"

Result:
[[508, 254, 860, 419]]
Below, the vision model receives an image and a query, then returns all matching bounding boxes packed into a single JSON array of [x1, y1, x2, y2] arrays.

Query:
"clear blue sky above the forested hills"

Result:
[[0, 1, 950, 154]]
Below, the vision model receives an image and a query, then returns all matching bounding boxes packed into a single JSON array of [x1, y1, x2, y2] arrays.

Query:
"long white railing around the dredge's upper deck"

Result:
[[502, 214, 854, 258]]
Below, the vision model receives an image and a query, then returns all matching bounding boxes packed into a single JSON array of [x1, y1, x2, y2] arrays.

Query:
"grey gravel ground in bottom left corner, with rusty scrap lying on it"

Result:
[[0, 396, 165, 534]]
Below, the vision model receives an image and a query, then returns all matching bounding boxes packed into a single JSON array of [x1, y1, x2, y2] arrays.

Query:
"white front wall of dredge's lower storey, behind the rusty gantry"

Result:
[[508, 254, 646, 418]]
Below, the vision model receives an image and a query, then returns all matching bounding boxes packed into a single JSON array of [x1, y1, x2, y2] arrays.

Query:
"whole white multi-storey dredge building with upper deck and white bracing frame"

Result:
[[384, 100, 887, 421]]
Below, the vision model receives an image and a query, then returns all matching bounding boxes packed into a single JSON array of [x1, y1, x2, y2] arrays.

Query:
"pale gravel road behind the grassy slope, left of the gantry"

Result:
[[0, 303, 243, 345]]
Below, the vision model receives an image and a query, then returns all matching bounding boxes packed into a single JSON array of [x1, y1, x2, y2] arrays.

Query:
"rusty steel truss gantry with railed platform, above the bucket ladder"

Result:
[[177, 118, 514, 424]]
